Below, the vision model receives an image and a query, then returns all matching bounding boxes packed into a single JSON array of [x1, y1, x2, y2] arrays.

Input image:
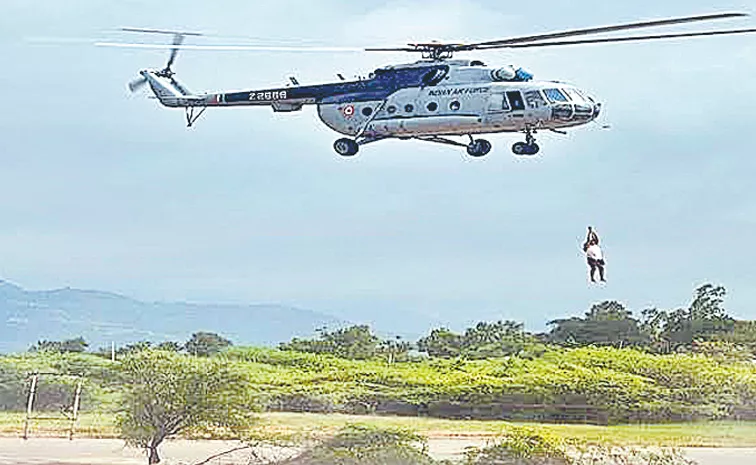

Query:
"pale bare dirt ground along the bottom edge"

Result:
[[0, 438, 756, 465]]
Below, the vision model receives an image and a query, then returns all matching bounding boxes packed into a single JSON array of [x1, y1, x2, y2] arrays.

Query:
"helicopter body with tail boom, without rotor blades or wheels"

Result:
[[142, 60, 601, 155]]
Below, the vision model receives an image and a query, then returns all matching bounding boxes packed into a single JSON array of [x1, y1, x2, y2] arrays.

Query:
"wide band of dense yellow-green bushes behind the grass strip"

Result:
[[5, 347, 756, 423]]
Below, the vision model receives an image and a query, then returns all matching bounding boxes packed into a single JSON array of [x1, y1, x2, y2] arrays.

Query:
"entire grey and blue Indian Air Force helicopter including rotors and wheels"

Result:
[[102, 13, 756, 157]]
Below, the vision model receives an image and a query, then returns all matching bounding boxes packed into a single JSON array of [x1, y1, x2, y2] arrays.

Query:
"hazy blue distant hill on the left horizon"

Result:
[[0, 281, 348, 353]]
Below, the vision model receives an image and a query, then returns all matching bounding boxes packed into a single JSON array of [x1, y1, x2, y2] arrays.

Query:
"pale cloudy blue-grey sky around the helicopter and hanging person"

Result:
[[0, 0, 756, 329]]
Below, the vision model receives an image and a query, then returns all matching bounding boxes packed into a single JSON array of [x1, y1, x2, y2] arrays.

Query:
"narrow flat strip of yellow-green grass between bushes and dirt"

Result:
[[0, 413, 756, 447]]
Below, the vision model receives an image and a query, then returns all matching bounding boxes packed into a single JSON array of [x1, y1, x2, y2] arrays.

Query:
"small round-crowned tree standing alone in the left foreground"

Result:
[[118, 350, 254, 464]]
